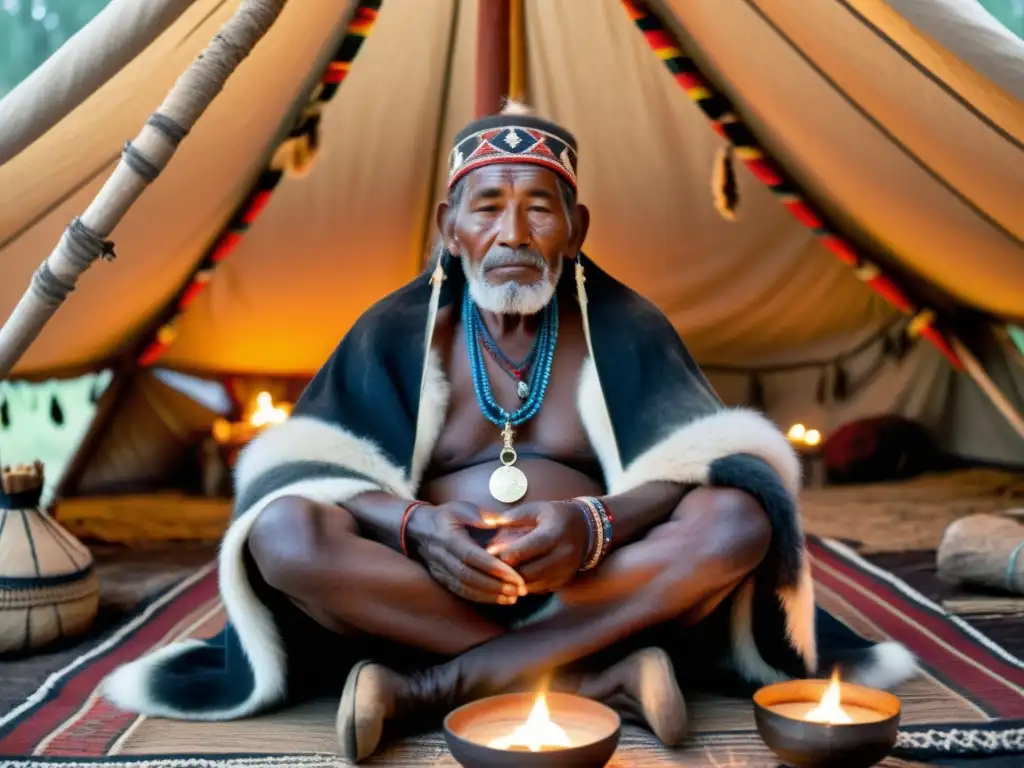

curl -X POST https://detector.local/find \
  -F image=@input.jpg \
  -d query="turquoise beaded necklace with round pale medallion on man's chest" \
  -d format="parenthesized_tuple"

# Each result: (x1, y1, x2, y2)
(462, 286, 558, 504)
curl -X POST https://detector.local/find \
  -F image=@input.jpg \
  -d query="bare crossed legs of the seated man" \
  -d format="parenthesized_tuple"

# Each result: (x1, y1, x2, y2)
(249, 487, 771, 758)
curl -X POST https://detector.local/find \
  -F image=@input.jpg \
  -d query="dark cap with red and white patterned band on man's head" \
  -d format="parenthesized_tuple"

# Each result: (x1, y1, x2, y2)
(447, 115, 577, 189)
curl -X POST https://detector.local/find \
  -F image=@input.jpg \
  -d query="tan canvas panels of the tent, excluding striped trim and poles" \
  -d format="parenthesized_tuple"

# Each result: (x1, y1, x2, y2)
(0, 0, 1024, 475)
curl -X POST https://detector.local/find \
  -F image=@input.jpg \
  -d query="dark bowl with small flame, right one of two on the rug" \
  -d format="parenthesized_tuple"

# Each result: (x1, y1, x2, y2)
(754, 673, 901, 768)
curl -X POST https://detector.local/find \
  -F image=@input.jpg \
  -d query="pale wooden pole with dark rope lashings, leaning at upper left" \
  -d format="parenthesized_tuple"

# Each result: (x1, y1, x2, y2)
(0, 0, 286, 377)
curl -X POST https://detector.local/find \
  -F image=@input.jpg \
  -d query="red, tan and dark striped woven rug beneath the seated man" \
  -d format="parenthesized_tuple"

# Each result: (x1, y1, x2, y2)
(0, 539, 1024, 768)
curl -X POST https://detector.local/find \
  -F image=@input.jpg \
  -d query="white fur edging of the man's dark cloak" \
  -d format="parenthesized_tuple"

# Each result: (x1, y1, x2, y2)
(103, 354, 913, 720)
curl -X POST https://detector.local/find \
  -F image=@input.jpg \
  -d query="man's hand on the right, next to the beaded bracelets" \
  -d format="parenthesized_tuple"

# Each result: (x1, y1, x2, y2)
(487, 502, 590, 594)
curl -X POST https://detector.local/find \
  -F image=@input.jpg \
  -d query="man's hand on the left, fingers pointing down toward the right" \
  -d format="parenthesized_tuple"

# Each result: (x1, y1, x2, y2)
(407, 502, 526, 605)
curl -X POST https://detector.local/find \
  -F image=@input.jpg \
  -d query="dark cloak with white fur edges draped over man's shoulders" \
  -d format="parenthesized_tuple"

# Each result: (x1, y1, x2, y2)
(104, 257, 914, 720)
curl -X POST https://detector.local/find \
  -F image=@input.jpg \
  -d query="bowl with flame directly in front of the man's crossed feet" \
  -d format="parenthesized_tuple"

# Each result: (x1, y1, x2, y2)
(444, 692, 622, 768)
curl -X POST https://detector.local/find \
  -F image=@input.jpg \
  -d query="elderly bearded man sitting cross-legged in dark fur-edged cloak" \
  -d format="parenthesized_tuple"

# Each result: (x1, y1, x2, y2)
(106, 105, 912, 760)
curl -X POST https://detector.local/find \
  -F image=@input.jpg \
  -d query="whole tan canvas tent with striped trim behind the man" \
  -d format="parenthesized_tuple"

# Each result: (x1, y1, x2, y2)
(0, 0, 1024, 505)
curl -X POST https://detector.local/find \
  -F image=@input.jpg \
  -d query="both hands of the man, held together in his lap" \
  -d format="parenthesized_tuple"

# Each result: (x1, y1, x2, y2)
(409, 502, 591, 605)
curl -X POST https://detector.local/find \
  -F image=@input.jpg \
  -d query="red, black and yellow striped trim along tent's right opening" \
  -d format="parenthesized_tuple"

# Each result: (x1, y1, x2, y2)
(622, 0, 965, 371)
